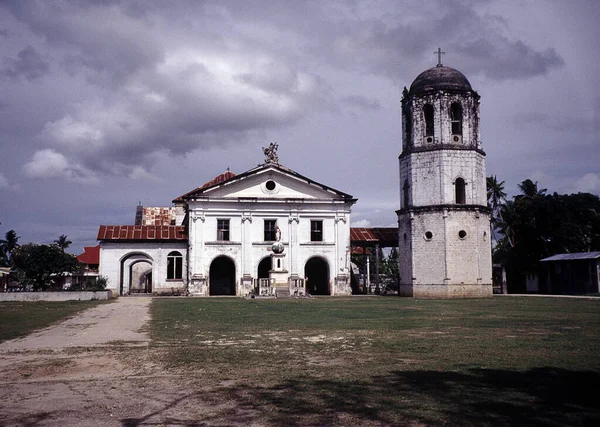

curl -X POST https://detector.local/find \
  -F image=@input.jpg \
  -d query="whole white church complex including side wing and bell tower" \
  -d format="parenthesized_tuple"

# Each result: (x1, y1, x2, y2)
(98, 53, 492, 298)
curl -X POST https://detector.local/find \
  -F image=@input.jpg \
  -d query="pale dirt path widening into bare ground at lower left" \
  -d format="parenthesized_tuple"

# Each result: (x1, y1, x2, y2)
(0, 297, 211, 426)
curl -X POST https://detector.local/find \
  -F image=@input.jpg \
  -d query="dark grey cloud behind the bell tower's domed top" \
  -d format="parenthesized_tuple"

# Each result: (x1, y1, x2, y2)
(312, 1, 564, 80)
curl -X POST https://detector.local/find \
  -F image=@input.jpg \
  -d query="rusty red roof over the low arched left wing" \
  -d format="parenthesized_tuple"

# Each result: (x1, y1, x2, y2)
(97, 225, 188, 241)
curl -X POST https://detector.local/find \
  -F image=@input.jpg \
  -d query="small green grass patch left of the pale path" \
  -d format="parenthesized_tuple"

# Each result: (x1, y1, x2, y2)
(0, 301, 101, 342)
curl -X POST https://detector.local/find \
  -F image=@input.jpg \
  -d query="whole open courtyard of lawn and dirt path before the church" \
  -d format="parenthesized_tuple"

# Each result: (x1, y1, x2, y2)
(0, 296, 600, 426)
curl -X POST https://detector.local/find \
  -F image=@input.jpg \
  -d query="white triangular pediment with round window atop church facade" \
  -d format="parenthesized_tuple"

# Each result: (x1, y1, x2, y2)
(182, 164, 352, 200)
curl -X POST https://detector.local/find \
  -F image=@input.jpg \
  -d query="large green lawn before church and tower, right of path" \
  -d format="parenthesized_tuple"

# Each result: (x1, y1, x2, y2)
(150, 297, 600, 427)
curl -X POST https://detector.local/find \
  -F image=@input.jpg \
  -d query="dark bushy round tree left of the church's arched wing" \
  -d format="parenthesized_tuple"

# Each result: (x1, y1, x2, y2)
(13, 243, 79, 291)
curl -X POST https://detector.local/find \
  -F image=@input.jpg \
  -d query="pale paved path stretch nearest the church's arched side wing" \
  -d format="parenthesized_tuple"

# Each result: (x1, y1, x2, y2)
(0, 297, 151, 354)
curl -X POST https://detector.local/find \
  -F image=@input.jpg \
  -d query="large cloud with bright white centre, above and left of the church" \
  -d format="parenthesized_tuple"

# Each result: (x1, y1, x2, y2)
(2, 2, 329, 179)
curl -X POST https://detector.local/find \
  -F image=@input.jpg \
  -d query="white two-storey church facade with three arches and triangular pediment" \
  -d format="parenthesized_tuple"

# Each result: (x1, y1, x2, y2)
(180, 164, 355, 295)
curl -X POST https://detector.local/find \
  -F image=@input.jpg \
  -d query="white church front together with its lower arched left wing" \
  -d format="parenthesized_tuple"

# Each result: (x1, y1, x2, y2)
(98, 163, 356, 296)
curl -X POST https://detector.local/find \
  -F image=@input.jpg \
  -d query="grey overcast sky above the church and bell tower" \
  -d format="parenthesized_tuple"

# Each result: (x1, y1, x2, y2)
(0, 0, 600, 253)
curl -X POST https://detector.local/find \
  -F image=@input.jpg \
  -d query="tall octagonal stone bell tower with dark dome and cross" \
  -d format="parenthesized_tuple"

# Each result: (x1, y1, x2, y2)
(397, 49, 492, 298)
